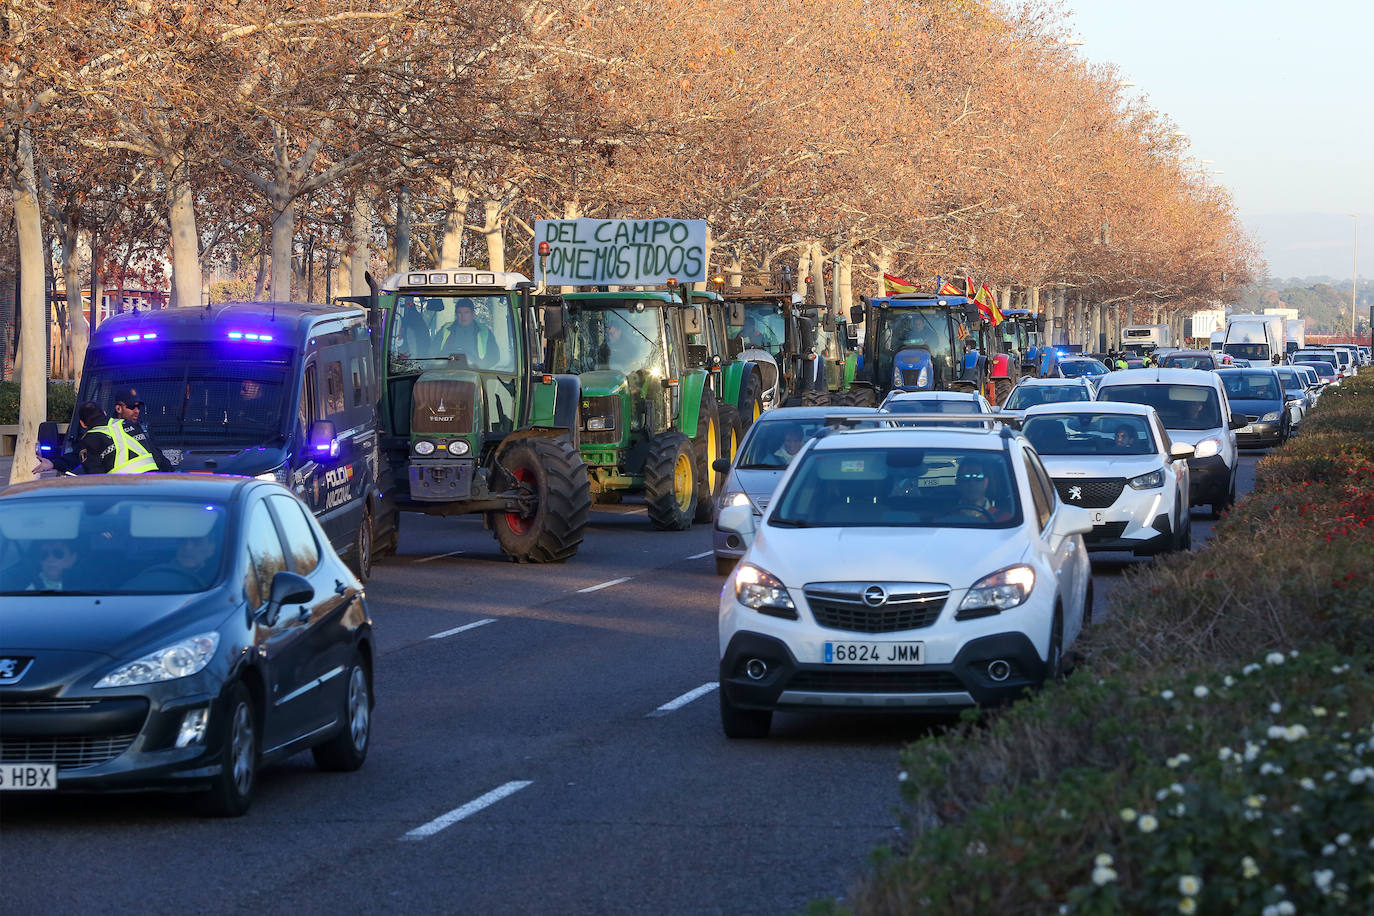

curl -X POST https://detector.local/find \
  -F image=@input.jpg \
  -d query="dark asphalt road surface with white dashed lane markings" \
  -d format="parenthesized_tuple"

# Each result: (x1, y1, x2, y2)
(0, 453, 1257, 915)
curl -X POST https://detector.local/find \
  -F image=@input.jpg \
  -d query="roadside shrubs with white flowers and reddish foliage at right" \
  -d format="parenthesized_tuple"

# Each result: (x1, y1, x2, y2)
(815, 372, 1374, 916)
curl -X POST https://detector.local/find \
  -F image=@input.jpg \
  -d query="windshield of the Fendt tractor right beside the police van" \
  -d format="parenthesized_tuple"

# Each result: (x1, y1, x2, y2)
(390, 293, 517, 372)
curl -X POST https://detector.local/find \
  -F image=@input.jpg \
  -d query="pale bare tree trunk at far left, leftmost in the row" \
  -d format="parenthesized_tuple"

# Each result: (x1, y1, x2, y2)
(10, 129, 46, 483)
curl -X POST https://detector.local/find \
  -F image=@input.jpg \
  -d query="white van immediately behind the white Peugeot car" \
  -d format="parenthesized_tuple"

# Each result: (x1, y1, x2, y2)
(1098, 369, 1245, 515)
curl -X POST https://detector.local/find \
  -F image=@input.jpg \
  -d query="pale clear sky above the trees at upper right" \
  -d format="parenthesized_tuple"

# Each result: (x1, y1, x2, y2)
(1063, 0, 1374, 283)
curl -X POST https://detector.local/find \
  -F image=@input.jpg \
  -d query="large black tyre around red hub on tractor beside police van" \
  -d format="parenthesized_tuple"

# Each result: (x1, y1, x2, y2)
(491, 437, 592, 563)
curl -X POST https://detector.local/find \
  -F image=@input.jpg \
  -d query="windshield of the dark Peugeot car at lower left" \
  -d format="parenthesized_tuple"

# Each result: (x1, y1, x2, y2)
(0, 496, 228, 598)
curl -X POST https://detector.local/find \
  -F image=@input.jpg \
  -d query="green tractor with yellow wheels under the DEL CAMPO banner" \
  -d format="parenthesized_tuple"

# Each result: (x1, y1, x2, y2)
(548, 290, 724, 530)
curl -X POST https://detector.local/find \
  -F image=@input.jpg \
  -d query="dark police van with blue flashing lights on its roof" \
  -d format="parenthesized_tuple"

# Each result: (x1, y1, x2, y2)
(50, 302, 398, 578)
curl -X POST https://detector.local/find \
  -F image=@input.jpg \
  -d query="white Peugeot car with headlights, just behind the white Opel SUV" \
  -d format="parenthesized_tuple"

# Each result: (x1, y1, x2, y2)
(1021, 401, 1193, 556)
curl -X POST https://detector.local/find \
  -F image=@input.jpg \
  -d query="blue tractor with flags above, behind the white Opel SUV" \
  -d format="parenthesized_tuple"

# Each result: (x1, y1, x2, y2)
(849, 293, 994, 401)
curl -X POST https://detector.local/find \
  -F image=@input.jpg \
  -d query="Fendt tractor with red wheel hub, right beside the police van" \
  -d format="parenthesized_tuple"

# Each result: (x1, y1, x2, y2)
(354, 268, 591, 563)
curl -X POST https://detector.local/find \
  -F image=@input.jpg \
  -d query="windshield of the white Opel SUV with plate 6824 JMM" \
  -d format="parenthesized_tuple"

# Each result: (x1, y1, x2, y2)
(768, 446, 1021, 527)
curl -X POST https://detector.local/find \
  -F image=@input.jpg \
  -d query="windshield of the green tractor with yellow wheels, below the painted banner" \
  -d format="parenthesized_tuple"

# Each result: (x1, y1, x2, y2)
(566, 301, 668, 378)
